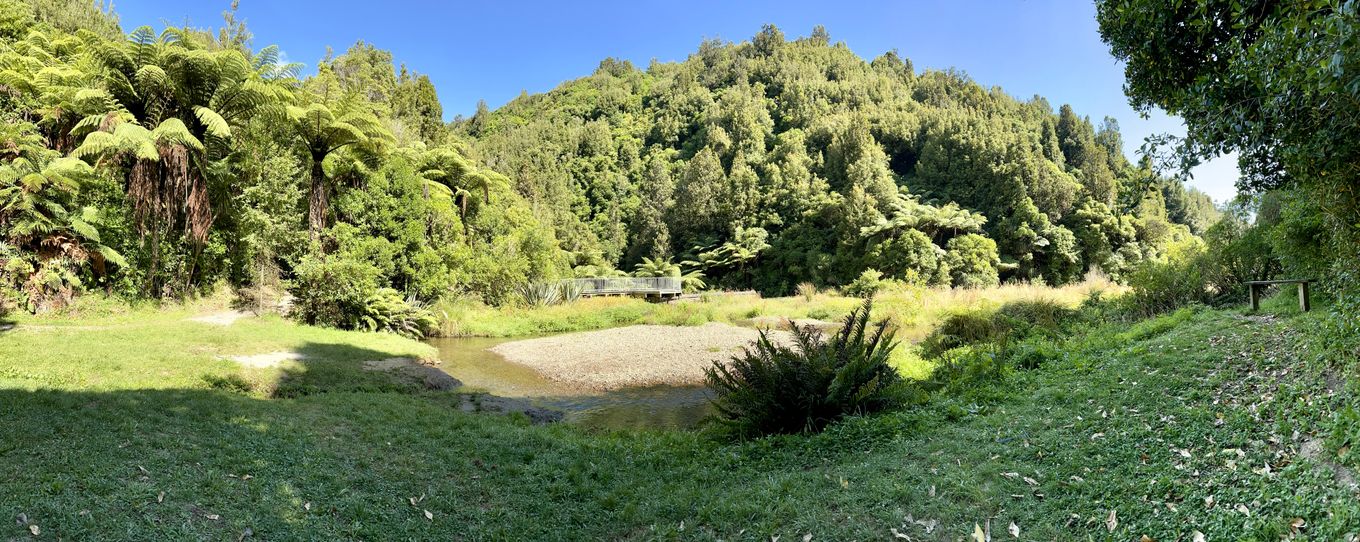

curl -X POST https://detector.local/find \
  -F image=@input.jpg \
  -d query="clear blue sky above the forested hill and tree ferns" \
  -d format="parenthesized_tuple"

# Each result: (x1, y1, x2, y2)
(116, 0, 1238, 201)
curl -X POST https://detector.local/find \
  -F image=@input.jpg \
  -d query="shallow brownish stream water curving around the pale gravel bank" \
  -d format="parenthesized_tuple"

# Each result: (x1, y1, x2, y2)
(428, 338, 711, 428)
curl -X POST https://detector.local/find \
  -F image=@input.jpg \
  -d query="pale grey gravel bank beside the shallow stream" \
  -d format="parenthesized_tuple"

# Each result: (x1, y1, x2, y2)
(491, 322, 789, 391)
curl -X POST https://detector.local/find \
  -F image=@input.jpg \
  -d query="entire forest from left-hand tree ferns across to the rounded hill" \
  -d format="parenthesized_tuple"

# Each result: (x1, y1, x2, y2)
(0, 0, 1216, 323)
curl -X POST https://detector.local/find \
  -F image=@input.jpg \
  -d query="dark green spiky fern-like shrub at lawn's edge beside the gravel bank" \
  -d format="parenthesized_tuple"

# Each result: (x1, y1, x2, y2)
(706, 302, 919, 436)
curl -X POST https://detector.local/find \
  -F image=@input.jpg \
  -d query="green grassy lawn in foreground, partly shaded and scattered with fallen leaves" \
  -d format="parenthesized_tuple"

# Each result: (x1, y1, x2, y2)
(0, 298, 1360, 541)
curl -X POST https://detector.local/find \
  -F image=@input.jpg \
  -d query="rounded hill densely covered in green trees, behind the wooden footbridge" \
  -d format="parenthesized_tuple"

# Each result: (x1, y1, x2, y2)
(456, 26, 1216, 292)
